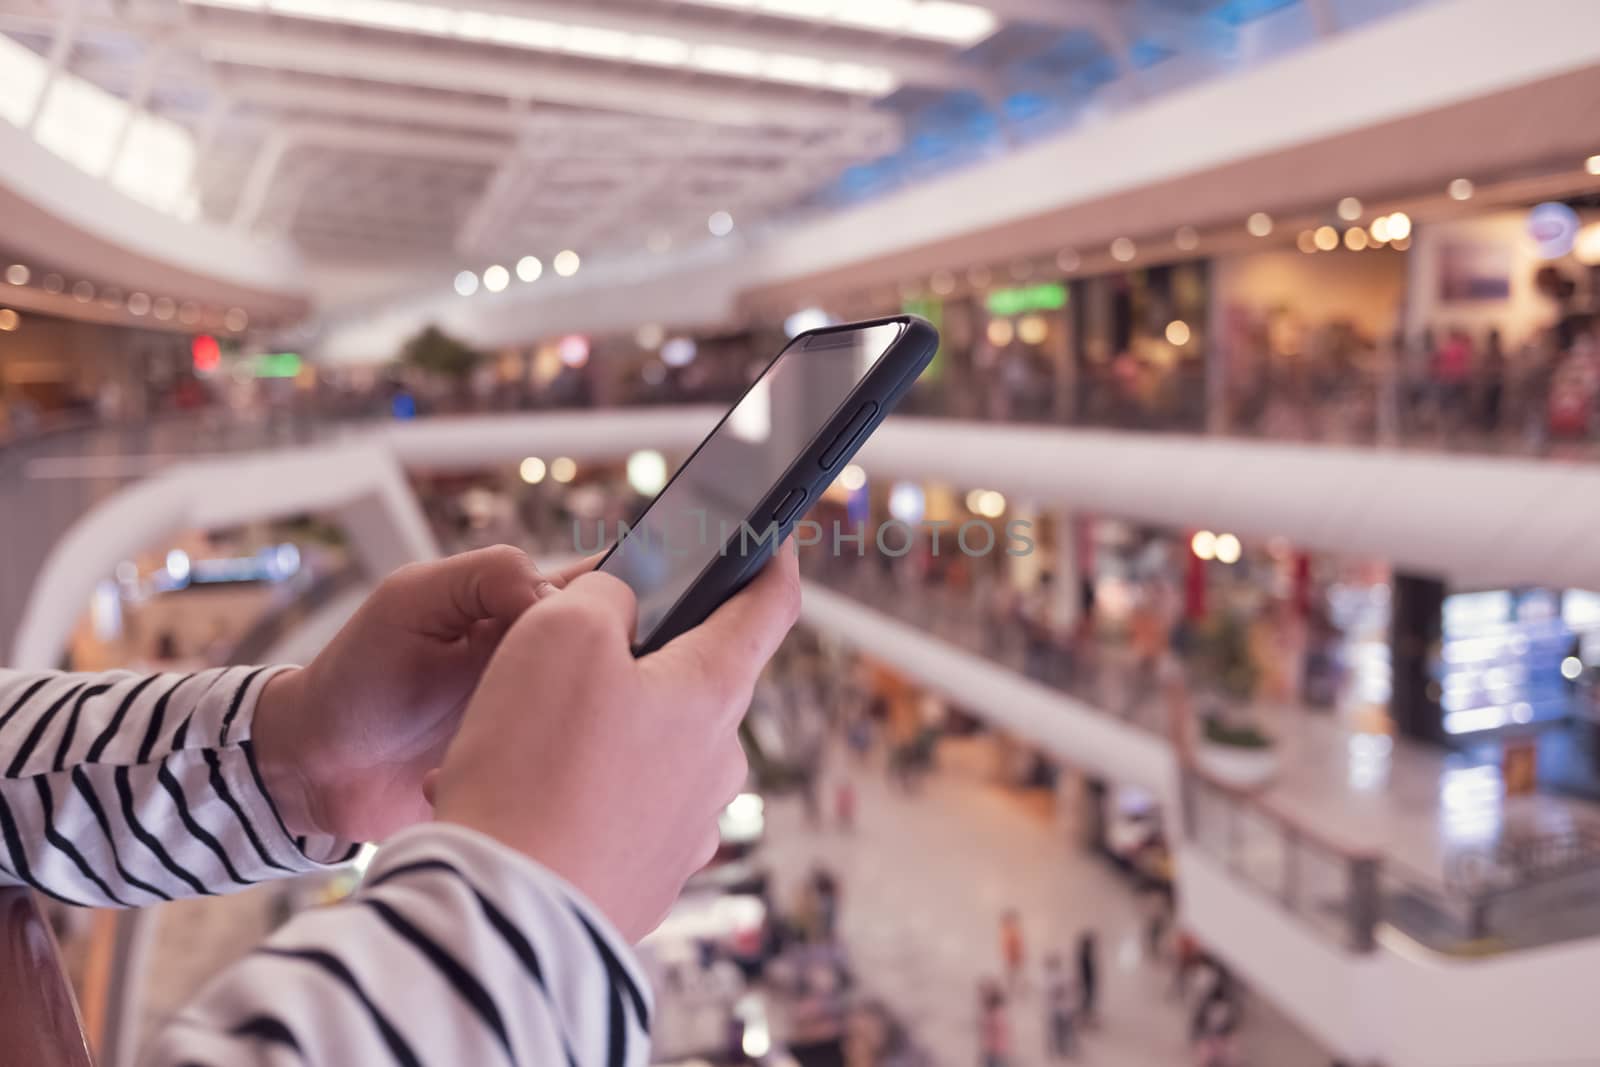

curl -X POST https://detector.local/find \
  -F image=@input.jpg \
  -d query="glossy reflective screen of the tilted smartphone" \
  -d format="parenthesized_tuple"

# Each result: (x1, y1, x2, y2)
(600, 323, 906, 643)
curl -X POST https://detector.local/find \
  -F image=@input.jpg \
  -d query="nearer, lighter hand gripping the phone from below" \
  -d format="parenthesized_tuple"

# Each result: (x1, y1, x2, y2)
(430, 545, 800, 939)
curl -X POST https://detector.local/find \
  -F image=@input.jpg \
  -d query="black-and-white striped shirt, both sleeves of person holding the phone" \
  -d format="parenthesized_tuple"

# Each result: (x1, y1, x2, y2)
(0, 667, 651, 1067)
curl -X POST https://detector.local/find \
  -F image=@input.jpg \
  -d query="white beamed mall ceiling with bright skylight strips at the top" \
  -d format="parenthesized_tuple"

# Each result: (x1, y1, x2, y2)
(0, 0, 1416, 292)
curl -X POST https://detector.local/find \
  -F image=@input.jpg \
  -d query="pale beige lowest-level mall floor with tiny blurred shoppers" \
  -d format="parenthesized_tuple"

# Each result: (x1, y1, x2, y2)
(762, 742, 1331, 1067)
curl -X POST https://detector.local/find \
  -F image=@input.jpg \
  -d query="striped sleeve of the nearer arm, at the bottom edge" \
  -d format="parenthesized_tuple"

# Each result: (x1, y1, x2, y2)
(144, 824, 651, 1067)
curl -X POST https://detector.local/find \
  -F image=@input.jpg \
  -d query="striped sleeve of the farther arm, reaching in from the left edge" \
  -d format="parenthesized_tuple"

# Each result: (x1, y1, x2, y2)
(0, 667, 355, 907)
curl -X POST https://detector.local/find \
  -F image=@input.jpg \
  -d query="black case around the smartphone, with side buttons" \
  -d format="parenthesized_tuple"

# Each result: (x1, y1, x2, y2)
(598, 315, 939, 656)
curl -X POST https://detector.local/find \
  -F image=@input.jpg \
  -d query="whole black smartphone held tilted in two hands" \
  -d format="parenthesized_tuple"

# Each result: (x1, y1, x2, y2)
(598, 315, 939, 656)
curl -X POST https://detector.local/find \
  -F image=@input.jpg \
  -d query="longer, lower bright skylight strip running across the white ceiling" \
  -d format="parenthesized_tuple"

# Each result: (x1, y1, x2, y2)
(187, 0, 902, 96)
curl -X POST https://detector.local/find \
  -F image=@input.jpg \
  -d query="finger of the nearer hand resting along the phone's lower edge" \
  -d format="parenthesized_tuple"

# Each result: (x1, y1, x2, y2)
(645, 539, 800, 710)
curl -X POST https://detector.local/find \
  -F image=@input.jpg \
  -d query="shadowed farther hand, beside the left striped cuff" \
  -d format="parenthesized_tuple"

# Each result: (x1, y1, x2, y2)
(253, 545, 595, 841)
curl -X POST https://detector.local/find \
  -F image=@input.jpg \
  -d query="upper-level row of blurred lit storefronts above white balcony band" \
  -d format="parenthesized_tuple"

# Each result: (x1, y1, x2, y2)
(0, 254, 1600, 467)
